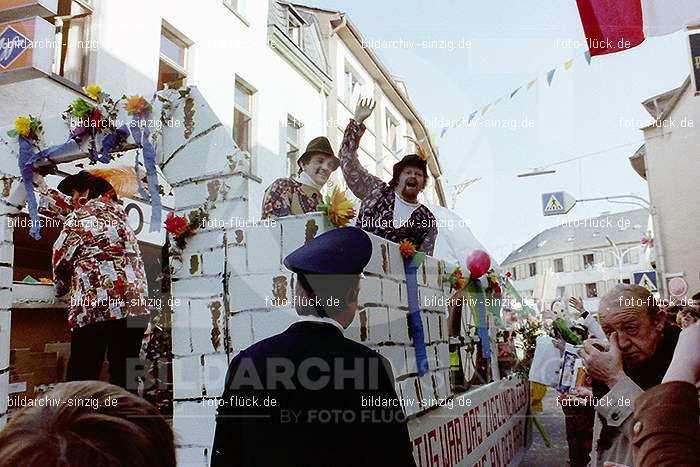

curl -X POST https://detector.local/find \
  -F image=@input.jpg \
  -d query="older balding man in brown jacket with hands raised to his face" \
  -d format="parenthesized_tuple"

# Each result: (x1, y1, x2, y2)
(580, 284, 679, 467)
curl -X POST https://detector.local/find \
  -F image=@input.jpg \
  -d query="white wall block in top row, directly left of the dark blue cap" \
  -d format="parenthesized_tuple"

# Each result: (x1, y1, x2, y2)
(246, 224, 287, 274)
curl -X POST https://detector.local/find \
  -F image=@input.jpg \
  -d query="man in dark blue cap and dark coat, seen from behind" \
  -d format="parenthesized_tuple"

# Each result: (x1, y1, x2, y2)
(211, 227, 415, 467)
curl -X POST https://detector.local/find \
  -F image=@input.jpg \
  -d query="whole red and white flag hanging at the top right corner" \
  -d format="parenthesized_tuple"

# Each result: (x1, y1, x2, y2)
(576, 0, 700, 56)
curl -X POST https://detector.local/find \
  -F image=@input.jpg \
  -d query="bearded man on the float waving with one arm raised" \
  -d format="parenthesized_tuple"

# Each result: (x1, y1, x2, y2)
(338, 100, 437, 255)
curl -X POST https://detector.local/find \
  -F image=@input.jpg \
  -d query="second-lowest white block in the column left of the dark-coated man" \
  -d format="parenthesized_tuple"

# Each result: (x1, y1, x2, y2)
(173, 399, 217, 447)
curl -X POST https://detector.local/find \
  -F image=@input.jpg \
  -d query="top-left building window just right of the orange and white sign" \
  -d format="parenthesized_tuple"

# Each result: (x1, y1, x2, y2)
(47, 0, 92, 86)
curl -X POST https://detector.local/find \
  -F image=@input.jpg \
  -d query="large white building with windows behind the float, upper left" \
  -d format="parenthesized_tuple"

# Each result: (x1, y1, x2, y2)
(0, 0, 444, 219)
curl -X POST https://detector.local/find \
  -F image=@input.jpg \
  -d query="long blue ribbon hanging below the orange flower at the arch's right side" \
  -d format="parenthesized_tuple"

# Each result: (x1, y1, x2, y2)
(130, 112, 161, 232)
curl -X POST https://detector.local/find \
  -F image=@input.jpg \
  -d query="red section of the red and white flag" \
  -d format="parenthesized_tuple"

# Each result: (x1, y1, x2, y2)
(576, 0, 644, 57)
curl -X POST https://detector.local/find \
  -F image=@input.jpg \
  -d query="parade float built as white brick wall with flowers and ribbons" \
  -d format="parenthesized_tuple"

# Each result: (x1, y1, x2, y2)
(0, 87, 532, 466)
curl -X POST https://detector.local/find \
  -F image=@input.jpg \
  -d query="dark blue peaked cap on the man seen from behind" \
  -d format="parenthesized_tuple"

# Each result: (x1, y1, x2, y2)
(284, 227, 372, 274)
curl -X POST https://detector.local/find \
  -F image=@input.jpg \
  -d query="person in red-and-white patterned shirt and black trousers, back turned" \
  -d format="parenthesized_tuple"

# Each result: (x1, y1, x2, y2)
(35, 172, 149, 389)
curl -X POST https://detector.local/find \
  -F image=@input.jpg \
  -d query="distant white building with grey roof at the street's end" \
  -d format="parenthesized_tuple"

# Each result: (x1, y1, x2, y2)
(502, 209, 653, 311)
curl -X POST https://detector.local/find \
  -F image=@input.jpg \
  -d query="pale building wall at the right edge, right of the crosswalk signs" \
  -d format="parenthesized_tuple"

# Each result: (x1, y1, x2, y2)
(630, 77, 700, 297)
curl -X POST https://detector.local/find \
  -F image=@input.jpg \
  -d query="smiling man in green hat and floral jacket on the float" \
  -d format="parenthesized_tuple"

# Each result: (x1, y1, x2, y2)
(262, 136, 340, 219)
